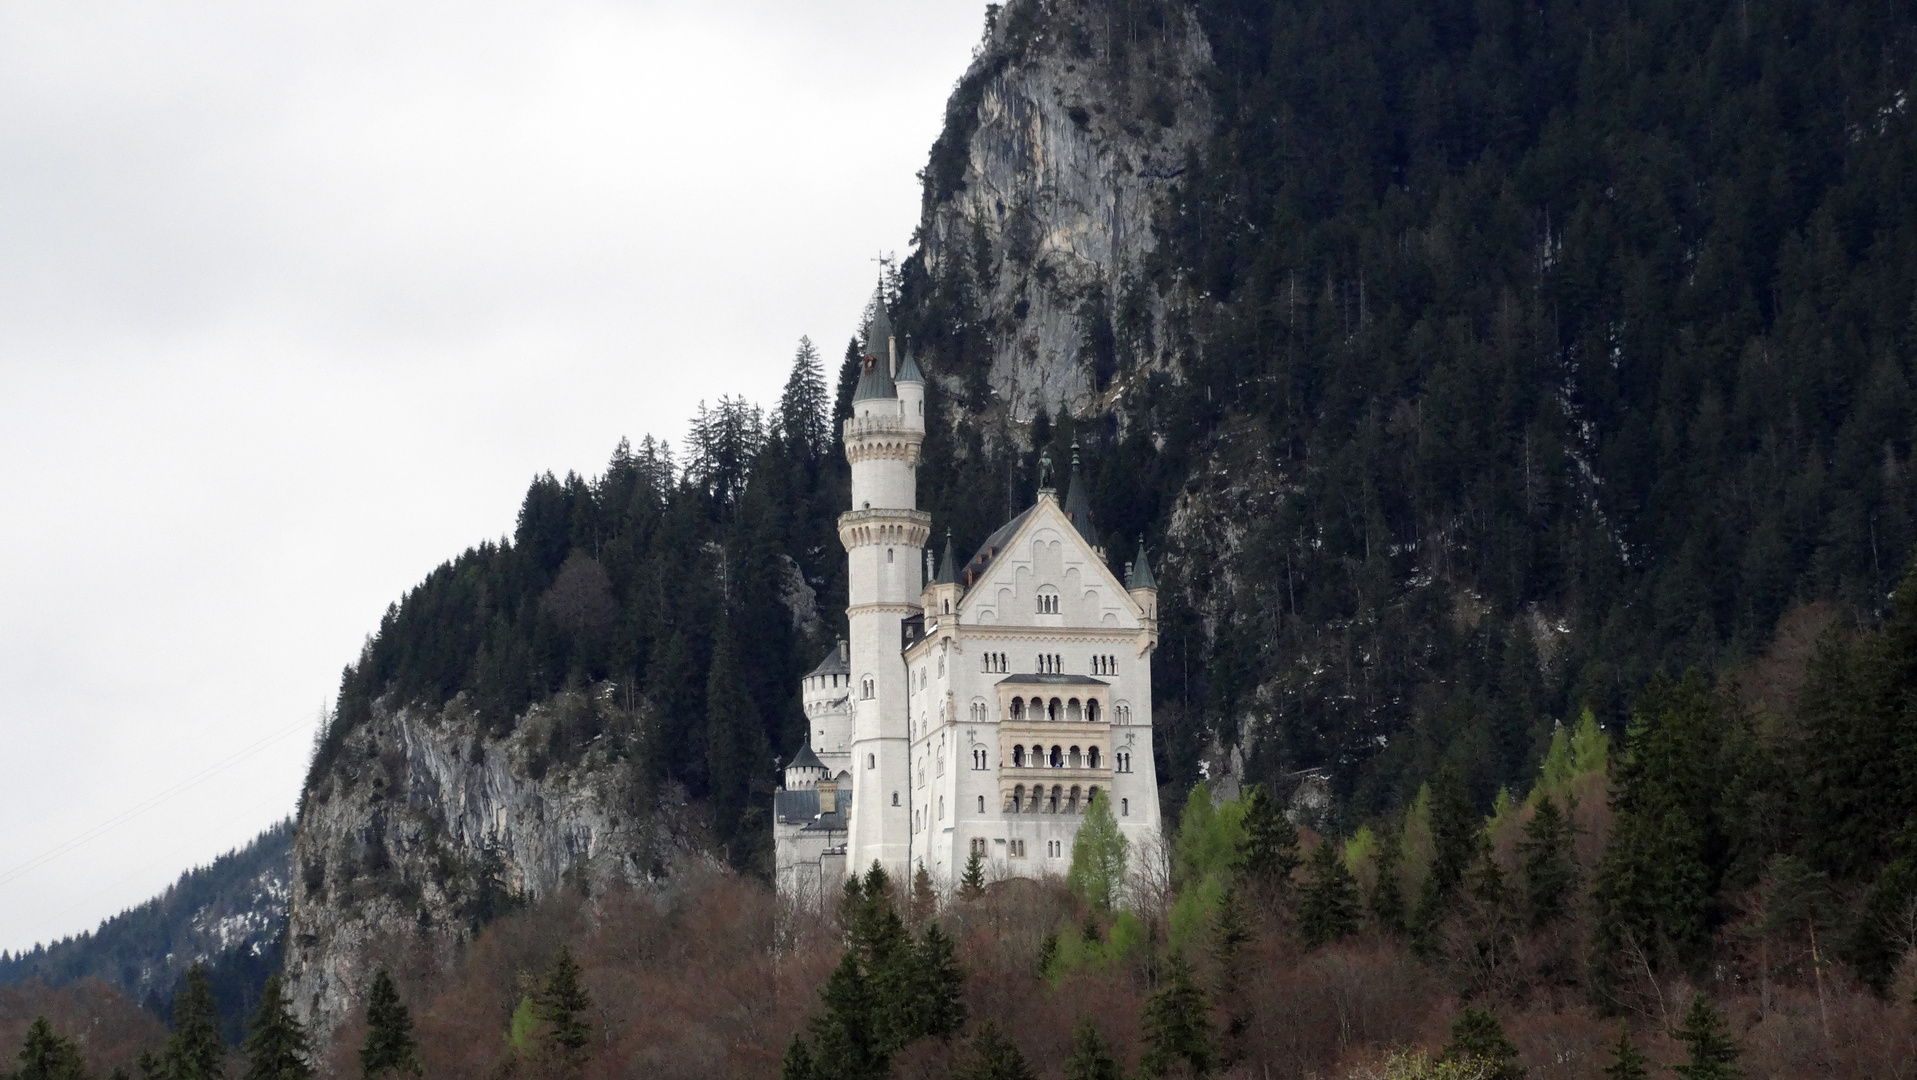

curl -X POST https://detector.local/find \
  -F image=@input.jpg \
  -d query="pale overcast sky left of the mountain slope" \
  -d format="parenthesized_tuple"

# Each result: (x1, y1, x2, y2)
(0, 0, 983, 950)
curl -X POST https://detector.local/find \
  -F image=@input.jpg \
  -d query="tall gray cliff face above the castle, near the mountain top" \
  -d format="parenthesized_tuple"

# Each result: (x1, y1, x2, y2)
(920, 2, 1212, 422)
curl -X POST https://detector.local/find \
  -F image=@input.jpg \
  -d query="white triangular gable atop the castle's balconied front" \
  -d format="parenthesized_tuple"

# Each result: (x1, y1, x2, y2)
(959, 493, 1141, 629)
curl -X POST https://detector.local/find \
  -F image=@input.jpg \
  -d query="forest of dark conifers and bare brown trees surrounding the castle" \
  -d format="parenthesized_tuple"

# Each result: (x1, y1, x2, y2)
(11, 0, 1917, 1080)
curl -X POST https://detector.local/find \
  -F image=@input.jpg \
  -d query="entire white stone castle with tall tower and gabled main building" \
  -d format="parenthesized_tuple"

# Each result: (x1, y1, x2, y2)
(773, 291, 1158, 902)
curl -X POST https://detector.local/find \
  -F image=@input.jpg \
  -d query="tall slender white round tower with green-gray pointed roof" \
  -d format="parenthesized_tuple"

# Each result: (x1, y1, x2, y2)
(840, 292, 932, 877)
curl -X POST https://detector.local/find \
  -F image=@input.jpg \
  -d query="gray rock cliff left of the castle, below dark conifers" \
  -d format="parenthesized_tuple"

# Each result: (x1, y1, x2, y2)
(286, 687, 688, 1042)
